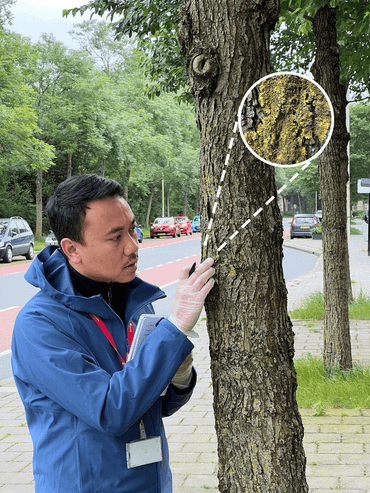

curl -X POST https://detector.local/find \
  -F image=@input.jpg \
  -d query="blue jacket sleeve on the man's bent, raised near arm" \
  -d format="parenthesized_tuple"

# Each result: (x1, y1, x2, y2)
(12, 310, 193, 436)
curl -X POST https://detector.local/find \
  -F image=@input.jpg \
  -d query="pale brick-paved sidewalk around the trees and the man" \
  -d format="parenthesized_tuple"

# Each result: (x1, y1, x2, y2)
(0, 236, 370, 493)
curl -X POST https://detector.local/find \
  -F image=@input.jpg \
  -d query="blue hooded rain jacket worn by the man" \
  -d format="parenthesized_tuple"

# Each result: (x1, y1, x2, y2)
(12, 247, 196, 493)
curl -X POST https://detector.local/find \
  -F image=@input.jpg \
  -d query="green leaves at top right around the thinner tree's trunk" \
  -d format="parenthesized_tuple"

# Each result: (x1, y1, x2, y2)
(272, 0, 370, 98)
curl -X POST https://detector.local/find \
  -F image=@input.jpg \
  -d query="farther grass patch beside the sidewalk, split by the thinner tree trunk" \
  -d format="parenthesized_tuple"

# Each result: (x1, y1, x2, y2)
(290, 292, 370, 320)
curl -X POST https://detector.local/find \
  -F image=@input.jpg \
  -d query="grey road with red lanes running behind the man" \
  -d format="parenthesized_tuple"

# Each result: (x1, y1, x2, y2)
(0, 234, 317, 379)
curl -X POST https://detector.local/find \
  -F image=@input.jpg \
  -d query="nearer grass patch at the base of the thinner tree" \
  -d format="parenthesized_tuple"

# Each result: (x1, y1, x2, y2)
(294, 354, 370, 408)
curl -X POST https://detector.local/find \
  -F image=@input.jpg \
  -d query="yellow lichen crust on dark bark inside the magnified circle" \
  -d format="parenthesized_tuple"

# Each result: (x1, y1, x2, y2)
(244, 74, 331, 164)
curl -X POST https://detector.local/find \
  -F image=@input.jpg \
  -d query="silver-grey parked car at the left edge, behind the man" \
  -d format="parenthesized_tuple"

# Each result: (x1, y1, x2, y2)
(0, 216, 35, 263)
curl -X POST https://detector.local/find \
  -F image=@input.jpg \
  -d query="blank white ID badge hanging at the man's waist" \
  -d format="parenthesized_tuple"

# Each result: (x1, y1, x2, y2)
(126, 437, 162, 469)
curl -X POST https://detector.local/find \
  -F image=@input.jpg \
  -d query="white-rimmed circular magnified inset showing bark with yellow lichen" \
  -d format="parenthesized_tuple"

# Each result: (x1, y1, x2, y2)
(238, 72, 334, 168)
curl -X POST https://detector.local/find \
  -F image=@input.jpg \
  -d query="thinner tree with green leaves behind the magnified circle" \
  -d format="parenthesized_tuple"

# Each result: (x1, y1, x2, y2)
(273, 0, 370, 369)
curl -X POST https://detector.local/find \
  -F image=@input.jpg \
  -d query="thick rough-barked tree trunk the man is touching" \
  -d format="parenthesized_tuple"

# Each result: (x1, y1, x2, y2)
(178, 0, 308, 493)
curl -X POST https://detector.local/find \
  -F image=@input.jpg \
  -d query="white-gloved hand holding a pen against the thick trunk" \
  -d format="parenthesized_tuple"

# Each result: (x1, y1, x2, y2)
(169, 258, 215, 337)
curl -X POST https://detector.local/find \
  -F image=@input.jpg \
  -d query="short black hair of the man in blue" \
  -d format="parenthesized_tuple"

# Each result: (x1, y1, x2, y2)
(45, 174, 124, 245)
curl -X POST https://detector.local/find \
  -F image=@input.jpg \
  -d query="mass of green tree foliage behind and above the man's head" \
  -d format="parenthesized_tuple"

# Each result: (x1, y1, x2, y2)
(0, 22, 199, 233)
